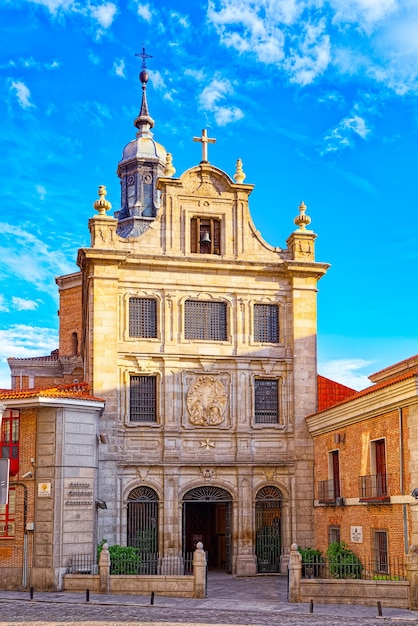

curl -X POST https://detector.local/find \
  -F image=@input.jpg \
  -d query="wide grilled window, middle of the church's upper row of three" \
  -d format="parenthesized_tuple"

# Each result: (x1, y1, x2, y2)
(184, 300, 227, 341)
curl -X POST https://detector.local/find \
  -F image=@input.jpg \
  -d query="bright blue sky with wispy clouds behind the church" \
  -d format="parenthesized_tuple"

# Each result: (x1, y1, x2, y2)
(0, 0, 418, 388)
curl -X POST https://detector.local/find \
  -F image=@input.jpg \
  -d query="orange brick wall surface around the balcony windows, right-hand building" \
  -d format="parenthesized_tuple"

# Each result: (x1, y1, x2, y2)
(314, 408, 411, 559)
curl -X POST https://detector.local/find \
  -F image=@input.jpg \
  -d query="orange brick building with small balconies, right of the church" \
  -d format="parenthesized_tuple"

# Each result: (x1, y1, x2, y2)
(307, 357, 418, 575)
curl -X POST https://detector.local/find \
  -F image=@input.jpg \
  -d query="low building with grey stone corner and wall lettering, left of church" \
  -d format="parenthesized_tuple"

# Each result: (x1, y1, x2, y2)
(0, 384, 104, 590)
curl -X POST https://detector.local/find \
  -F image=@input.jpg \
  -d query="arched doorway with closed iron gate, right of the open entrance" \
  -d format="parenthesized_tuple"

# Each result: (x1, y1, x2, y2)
(255, 485, 283, 572)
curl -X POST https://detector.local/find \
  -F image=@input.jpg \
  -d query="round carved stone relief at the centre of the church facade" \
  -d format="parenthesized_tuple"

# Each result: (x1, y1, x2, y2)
(186, 376, 228, 426)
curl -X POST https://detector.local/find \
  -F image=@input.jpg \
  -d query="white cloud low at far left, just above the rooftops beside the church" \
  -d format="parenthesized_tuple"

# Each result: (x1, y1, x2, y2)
(0, 324, 58, 389)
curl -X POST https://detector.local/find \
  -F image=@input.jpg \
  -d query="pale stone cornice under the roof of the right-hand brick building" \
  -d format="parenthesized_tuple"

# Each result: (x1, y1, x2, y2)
(306, 376, 418, 436)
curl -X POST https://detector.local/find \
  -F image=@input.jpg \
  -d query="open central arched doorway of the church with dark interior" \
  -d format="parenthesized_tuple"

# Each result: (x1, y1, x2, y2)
(183, 486, 232, 572)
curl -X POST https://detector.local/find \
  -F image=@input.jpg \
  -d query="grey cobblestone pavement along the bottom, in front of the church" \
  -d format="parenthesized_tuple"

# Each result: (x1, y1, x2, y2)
(0, 574, 418, 626)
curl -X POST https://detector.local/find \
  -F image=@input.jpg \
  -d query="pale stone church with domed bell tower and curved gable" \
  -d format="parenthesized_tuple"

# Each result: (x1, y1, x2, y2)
(5, 62, 328, 576)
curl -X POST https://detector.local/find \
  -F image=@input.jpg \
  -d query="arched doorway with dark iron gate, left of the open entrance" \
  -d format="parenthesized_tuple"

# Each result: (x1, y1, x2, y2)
(127, 487, 158, 559)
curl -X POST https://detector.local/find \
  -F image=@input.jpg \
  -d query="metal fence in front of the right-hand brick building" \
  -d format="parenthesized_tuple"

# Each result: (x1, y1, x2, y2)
(302, 555, 406, 581)
